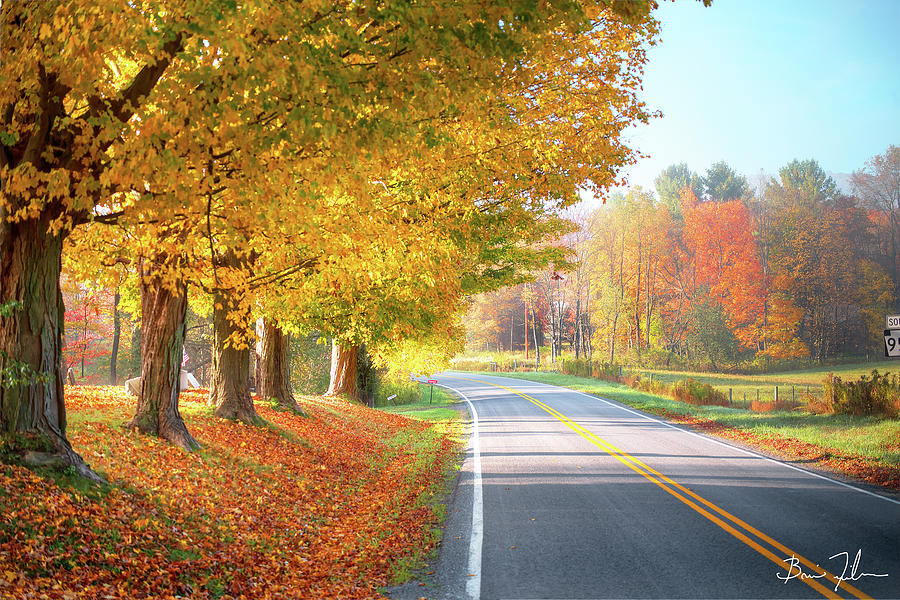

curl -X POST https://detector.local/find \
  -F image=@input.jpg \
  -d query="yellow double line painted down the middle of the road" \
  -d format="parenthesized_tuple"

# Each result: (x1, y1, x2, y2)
(458, 377, 871, 600)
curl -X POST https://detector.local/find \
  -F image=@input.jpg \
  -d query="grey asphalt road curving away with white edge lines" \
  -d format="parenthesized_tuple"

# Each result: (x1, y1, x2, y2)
(397, 373, 900, 599)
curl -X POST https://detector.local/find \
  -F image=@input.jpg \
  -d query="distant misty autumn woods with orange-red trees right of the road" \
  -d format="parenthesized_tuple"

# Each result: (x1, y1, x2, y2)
(467, 146, 900, 370)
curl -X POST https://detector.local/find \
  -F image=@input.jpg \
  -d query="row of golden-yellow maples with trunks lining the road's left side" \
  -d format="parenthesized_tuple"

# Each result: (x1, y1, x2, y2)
(0, 0, 657, 477)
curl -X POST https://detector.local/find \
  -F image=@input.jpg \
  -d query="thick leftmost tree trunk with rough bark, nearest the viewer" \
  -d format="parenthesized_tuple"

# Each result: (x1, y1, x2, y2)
(0, 213, 103, 481)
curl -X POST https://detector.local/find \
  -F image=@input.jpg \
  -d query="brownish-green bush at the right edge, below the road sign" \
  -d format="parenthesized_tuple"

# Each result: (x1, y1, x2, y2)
(822, 369, 900, 417)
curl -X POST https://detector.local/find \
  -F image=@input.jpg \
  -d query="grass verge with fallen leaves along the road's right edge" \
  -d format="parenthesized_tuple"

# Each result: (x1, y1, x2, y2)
(464, 370, 900, 489)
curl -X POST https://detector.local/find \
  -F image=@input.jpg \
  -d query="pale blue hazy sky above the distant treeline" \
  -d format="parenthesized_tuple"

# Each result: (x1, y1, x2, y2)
(590, 0, 900, 204)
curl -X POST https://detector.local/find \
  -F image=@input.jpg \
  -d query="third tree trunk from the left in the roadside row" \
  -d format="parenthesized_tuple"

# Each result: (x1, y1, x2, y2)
(209, 290, 259, 425)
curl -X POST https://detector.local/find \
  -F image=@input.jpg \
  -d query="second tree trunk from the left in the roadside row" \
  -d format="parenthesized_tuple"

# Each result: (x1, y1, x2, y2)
(126, 260, 200, 450)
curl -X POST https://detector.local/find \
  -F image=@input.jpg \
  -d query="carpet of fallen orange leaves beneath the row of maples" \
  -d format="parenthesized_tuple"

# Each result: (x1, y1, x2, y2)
(0, 387, 456, 599)
